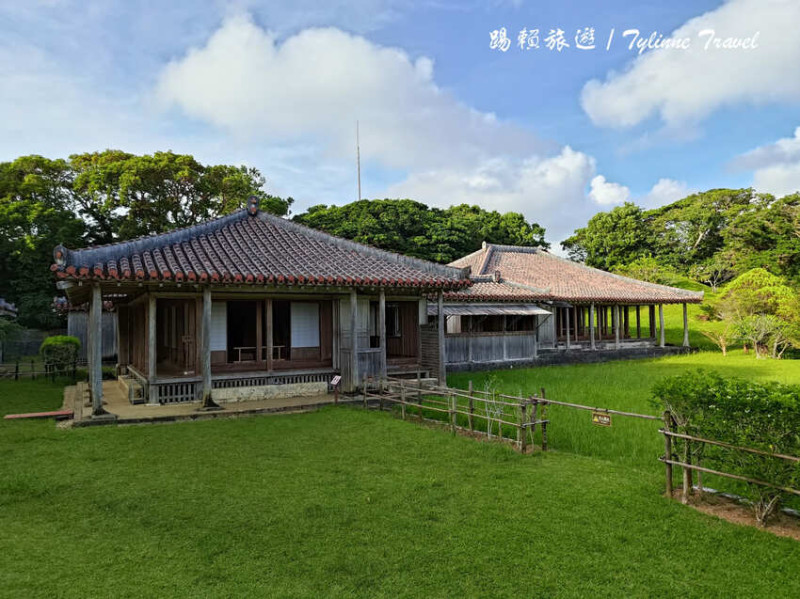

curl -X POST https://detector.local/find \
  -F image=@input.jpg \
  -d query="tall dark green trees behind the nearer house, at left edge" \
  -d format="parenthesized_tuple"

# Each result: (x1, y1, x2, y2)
(0, 150, 293, 328)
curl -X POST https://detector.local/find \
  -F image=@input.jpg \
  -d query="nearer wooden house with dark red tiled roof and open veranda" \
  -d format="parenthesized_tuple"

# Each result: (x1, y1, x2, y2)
(52, 199, 470, 414)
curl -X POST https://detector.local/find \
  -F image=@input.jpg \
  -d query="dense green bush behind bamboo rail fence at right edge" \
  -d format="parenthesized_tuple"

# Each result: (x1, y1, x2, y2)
(653, 370, 800, 524)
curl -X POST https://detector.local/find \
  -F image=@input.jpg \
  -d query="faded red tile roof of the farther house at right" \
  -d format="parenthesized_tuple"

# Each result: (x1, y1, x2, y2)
(447, 244, 703, 304)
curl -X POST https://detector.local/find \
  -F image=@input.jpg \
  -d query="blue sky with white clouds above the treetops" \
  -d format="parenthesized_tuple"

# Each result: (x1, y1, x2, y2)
(0, 0, 800, 242)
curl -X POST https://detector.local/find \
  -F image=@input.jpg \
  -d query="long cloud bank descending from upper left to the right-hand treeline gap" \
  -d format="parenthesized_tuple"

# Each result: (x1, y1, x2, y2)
(156, 16, 627, 241)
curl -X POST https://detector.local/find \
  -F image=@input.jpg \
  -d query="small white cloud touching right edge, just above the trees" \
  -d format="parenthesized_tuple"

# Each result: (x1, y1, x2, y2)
(733, 127, 800, 197)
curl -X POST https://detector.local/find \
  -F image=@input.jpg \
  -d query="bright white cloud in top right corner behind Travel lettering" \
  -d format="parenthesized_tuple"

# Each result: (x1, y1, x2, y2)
(581, 0, 800, 129)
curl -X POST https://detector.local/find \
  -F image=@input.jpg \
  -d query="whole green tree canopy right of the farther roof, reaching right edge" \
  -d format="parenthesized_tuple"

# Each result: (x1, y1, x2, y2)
(562, 189, 800, 287)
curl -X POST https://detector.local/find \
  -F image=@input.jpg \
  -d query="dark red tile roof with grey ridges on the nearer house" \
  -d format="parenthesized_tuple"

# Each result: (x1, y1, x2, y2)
(51, 207, 470, 289)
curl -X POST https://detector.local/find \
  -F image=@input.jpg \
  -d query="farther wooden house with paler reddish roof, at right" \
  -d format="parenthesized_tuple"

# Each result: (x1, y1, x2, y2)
(438, 243, 703, 370)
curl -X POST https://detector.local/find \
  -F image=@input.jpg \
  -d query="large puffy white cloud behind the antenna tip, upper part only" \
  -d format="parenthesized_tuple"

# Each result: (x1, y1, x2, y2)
(157, 16, 545, 169)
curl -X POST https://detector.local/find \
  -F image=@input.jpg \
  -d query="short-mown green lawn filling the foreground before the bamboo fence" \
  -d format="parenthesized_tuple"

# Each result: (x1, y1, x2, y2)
(0, 378, 800, 597)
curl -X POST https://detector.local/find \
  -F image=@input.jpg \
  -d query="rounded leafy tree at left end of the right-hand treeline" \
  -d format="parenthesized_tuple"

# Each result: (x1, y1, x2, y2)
(561, 202, 653, 270)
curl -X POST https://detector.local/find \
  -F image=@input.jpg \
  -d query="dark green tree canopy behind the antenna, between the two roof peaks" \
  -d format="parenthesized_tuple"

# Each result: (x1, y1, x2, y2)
(294, 199, 548, 263)
